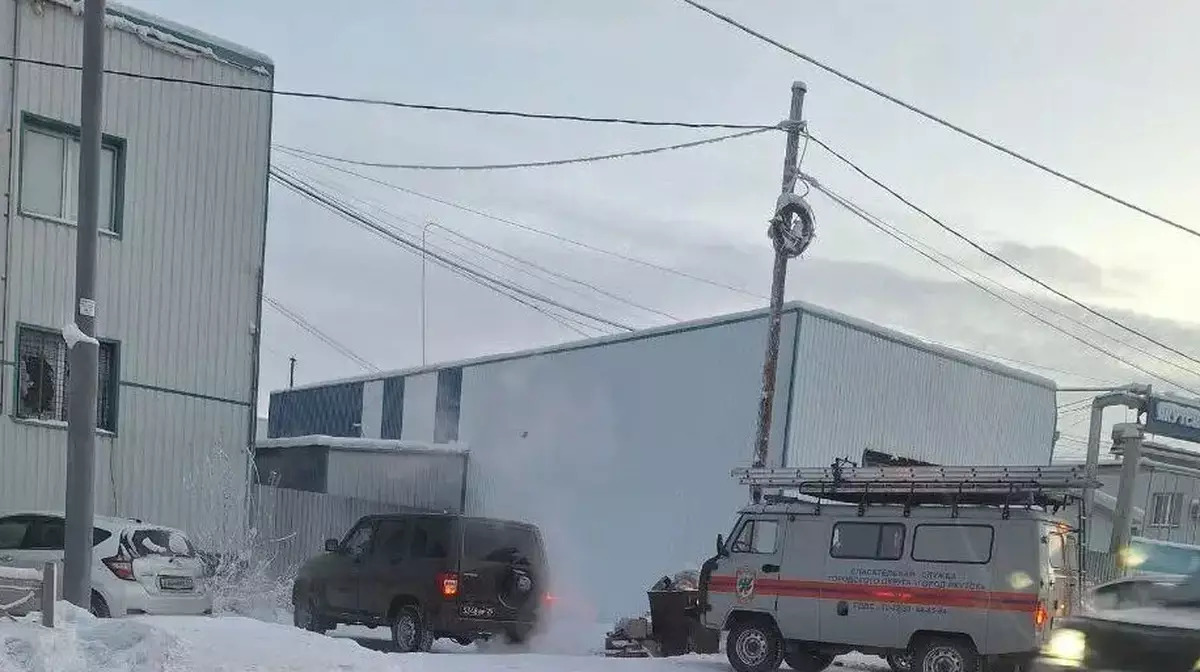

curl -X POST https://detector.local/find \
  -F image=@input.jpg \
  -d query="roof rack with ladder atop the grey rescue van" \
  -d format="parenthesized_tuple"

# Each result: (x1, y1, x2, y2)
(733, 462, 1100, 514)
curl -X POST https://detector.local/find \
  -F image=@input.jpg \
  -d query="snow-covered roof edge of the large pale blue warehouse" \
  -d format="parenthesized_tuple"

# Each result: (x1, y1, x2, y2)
(278, 301, 1058, 396)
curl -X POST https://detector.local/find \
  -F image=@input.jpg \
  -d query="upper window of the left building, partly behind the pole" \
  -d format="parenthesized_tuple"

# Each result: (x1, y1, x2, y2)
(20, 114, 125, 233)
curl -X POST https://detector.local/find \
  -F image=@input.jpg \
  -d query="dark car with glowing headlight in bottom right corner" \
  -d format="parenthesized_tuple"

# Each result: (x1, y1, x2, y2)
(1033, 572, 1200, 672)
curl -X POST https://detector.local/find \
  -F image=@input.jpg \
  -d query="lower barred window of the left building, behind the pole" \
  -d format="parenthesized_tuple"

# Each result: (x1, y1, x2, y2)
(16, 326, 118, 432)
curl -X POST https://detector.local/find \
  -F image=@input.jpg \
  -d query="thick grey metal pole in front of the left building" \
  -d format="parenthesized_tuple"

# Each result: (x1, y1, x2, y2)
(62, 0, 104, 608)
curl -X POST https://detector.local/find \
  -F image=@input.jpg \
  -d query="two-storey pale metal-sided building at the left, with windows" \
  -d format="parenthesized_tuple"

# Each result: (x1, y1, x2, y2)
(0, 0, 274, 540)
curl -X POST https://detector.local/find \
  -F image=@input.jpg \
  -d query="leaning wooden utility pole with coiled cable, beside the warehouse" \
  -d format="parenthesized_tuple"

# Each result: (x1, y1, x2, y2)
(750, 82, 808, 503)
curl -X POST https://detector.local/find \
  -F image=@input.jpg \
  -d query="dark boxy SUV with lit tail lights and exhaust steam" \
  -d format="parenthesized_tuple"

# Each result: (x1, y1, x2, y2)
(292, 514, 548, 652)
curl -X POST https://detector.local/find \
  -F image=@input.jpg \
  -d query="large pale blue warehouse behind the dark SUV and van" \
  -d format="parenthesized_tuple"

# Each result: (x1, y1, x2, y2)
(269, 304, 1056, 616)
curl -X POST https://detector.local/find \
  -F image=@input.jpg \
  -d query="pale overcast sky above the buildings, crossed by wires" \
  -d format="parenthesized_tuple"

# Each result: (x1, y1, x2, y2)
(128, 0, 1200, 453)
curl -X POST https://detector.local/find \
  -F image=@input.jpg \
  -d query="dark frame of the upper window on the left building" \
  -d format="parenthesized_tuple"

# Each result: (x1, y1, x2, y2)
(16, 112, 128, 239)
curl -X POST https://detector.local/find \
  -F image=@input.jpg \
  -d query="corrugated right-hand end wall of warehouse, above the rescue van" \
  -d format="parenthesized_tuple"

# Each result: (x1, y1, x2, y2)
(787, 312, 1057, 467)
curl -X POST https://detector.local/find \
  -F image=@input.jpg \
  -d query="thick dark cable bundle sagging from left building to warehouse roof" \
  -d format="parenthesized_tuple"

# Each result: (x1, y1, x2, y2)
(270, 167, 634, 331)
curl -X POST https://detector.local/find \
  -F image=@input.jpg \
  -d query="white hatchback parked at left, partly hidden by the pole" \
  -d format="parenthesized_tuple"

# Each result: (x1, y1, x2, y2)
(0, 512, 212, 618)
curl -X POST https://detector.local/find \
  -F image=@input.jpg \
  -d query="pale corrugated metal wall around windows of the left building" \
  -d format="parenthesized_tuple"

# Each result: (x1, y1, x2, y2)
(0, 0, 271, 540)
